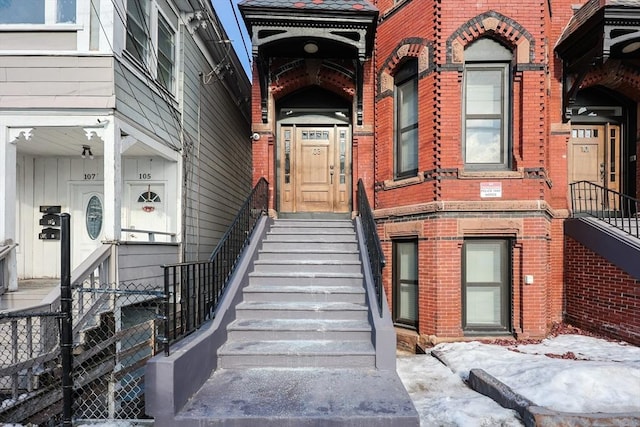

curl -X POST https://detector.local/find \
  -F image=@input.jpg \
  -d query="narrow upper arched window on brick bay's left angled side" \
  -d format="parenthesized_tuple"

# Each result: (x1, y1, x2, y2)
(394, 58, 418, 179)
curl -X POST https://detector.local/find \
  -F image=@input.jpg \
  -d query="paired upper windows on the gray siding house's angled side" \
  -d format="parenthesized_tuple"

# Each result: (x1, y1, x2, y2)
(125, 0, 176, 91)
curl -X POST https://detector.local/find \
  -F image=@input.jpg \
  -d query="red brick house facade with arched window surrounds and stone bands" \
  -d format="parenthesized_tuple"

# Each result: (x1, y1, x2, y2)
(244, 0, 640, 342)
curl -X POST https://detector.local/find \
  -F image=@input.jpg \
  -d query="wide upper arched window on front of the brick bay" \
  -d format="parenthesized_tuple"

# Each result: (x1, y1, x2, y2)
(463, 38, 512, 170)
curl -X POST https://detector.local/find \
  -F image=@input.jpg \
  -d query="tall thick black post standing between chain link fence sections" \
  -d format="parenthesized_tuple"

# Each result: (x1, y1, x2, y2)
(60, 213, 73, 426)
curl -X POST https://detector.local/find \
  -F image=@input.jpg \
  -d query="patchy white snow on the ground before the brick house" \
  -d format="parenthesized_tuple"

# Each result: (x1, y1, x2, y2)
(398, 335, 640, 427)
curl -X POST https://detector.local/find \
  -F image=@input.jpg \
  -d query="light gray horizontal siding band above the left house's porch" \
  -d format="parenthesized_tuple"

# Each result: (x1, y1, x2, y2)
(0, 56, 115, 109)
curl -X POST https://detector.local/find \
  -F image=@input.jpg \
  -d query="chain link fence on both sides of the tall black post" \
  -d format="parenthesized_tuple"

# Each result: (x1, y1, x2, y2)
(0, 280, 165, 426)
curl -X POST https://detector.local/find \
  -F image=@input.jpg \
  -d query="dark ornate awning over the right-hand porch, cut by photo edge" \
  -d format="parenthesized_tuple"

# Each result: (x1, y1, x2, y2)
(555, 0, 640, 121)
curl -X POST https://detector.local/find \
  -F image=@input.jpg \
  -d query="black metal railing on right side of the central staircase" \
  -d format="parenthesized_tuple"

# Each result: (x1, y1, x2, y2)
(356, 179, 386, 316)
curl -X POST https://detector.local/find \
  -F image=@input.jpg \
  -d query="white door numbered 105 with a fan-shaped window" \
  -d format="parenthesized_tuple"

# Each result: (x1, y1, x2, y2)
(122, 183, 170, 242)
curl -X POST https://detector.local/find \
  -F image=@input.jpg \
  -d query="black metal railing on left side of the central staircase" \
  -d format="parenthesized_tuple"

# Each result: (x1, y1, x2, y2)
(160, 178, 269, 356)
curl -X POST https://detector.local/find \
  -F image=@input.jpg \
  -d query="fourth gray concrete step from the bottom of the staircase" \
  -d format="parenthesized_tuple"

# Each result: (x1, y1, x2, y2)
(243, 285, 366, 304)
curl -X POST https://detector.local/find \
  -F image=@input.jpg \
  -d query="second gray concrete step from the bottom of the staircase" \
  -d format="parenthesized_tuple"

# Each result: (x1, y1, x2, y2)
(227, 319, 371, 341)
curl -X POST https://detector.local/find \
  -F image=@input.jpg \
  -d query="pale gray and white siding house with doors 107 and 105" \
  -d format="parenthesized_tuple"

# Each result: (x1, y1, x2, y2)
(0, 0, 251, 294)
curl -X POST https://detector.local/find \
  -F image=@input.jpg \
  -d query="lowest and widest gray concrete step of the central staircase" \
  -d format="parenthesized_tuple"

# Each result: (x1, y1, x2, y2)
(218, 337, 376, 369)
